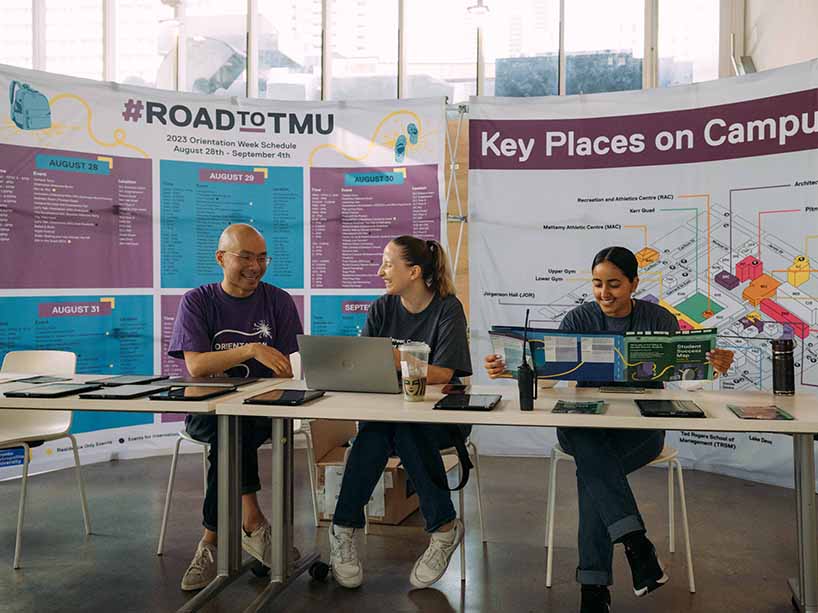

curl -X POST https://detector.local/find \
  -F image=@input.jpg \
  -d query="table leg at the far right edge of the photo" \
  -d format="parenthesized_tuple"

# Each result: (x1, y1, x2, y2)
(789, 434, 818, 613)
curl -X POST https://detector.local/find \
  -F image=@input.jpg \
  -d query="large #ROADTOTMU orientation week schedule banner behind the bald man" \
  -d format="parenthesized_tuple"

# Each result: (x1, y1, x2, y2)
(0, 66, 446, 478)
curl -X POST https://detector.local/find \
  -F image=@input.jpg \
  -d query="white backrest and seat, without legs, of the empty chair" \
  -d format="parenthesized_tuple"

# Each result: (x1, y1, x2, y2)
(0, 350, 77, 443)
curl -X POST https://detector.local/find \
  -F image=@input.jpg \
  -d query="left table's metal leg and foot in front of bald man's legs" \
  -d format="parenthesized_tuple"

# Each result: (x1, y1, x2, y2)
(178, 415, 252, 613)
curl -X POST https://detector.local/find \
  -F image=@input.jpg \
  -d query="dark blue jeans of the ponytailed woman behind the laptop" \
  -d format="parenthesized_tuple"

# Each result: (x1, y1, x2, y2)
(332, 422, 457, 532)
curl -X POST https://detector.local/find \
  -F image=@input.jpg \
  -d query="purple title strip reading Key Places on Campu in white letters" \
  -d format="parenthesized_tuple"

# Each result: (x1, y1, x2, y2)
(469, 89, 818, 170)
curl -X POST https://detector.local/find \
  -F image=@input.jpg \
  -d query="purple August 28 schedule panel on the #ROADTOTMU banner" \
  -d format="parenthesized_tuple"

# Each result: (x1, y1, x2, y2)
(0, 144, 153, 289)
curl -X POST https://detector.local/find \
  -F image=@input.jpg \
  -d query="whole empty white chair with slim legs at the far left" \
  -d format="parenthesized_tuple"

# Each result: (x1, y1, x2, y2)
(0, 351, 91, 569)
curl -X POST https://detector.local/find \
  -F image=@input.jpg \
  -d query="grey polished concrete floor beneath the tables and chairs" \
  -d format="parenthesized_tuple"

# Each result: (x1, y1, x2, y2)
(0, 450, 797, 613)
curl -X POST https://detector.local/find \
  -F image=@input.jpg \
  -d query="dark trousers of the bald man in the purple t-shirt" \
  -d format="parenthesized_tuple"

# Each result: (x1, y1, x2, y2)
(185, 414, 272, 532)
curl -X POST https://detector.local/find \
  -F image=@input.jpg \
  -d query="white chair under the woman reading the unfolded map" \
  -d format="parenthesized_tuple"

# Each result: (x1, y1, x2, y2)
(545, 445, 696, 594)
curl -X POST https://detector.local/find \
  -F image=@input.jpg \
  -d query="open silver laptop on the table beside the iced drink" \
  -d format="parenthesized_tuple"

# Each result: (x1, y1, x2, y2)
(298, 334, 401, 394)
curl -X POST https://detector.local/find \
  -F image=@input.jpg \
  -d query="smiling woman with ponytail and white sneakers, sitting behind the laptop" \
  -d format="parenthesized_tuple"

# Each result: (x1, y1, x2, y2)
(329, 236, 471, 588)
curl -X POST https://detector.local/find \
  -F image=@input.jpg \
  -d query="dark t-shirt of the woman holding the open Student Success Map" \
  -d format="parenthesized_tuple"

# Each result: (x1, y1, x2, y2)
(560, 300, 679, 389)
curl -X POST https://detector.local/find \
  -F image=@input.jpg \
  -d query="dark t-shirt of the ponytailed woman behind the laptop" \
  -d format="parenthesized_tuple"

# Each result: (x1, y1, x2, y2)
(361, 294, 472, 377)
